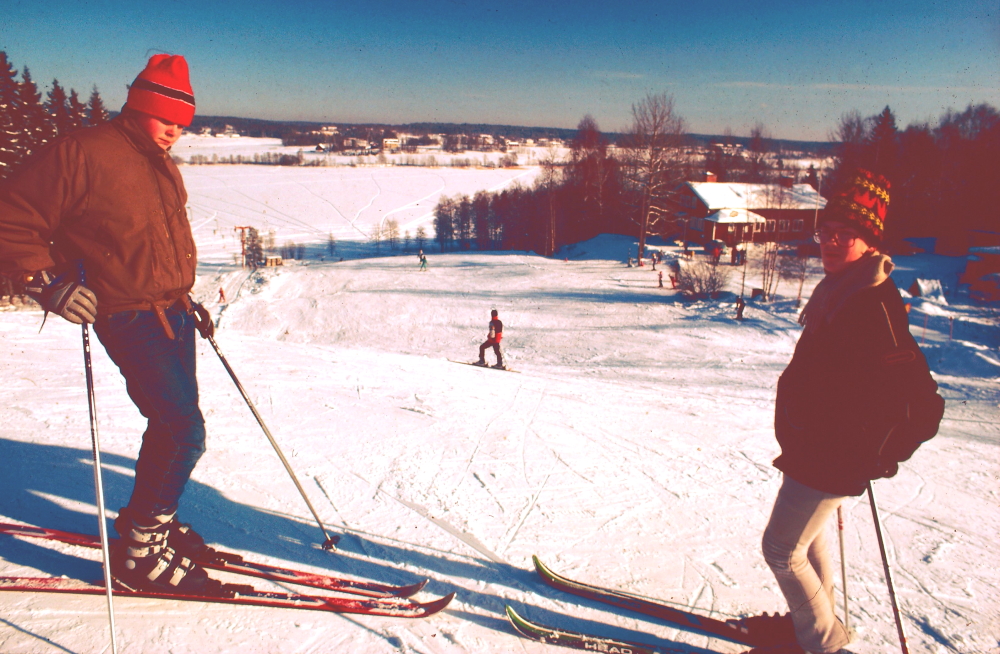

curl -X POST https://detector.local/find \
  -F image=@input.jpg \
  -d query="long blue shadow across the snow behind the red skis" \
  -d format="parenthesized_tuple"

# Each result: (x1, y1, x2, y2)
(0, 438, 720, 654)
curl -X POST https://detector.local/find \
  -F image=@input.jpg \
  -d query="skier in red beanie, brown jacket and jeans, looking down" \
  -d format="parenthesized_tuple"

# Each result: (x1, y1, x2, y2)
(0, 55, 219, 593)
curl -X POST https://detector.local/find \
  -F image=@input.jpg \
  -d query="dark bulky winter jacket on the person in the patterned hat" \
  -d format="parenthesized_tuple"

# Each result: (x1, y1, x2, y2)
(774, 279, 944, 495)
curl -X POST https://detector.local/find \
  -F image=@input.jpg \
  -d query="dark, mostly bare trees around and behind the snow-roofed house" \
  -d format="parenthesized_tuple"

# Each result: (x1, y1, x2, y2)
(434, 93, 1000, 257)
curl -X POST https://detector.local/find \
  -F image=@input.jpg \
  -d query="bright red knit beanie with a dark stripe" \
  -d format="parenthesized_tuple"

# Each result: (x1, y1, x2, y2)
(125, 55, 194, 127)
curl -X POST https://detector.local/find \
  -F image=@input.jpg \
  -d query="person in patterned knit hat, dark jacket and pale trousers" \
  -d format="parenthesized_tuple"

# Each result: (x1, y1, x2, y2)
(743, 170, 944, 654)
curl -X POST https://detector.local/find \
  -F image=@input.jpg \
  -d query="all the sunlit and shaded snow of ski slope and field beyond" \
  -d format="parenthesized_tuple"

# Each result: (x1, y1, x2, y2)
(0, 160, 1000, 654)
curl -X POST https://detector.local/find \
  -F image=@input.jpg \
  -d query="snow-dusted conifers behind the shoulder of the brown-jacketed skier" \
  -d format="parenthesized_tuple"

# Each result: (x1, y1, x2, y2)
(0, 50, 109, 179)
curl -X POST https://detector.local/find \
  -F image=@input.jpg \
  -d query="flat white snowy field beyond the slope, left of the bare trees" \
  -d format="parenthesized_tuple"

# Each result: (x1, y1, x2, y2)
(181, 164, 539, 263)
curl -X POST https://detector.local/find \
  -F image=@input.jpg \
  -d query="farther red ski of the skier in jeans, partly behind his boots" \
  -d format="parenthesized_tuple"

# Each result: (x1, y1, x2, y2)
(0, 522, 427, 597)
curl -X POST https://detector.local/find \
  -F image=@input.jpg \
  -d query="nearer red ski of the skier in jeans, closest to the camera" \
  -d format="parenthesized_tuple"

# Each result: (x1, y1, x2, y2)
(0, 577, 455, 618)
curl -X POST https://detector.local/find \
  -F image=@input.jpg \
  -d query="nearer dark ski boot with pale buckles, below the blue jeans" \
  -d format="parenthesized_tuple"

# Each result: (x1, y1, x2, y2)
(111, 511, 222, 595)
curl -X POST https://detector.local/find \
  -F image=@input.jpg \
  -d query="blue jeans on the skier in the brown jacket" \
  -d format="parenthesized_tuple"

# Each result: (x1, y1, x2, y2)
(94, 307, 205, 516)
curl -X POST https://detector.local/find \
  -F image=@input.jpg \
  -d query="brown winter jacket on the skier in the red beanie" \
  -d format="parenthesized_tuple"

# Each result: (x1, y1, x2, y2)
(0, 114, 197, 326)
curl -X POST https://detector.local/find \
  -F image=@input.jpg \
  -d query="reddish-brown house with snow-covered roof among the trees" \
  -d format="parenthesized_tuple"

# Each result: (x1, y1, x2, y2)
(676, 173, 826, 246)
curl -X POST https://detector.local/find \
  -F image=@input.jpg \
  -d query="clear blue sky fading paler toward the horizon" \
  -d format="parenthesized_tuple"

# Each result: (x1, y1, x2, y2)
(0, 0, 1000, 140)
